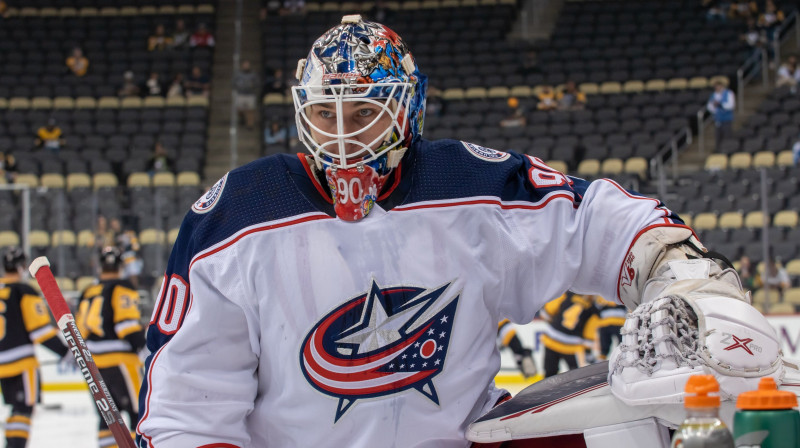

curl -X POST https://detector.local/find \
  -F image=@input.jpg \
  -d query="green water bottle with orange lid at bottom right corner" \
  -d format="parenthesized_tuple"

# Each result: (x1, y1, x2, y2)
(733, 377, 800, 448)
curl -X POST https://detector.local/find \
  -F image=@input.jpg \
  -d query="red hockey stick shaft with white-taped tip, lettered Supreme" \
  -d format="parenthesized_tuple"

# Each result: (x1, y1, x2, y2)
(28, 257, 136, 448)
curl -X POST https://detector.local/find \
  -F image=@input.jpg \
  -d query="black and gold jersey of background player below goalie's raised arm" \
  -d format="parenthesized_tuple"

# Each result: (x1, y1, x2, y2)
(540, 293, 599, 355)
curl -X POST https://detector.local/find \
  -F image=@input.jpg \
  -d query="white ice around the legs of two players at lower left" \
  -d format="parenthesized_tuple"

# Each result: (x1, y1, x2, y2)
(0, 390, 131, 448)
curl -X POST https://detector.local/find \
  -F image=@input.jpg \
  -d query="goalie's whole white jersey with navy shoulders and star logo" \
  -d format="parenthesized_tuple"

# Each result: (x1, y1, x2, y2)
(137, 140, 683, 448)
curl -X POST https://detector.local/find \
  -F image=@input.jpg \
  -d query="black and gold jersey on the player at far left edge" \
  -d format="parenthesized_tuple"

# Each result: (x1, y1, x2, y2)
(0, 278, 59, 378)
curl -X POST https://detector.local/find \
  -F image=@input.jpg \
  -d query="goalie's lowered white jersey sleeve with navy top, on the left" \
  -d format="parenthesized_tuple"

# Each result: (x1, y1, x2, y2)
(137, 212, 260, 448)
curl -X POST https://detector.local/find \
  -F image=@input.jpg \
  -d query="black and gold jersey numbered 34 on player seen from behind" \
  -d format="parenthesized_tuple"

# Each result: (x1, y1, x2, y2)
(75, 279, 144, 368)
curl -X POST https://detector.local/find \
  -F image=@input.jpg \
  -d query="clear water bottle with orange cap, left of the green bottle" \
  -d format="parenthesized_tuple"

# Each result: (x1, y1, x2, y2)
(671, 375, 734, 448)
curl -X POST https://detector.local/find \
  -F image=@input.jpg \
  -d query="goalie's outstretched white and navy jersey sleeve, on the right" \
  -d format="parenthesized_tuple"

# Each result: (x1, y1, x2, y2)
(500, 156, 686, 320)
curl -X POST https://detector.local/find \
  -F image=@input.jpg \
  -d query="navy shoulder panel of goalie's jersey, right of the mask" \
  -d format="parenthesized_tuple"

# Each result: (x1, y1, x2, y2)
(417, 140, 589, 204)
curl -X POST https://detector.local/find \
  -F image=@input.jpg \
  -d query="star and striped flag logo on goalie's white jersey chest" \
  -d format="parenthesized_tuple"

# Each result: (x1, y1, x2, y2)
(300, 279, 459, 422)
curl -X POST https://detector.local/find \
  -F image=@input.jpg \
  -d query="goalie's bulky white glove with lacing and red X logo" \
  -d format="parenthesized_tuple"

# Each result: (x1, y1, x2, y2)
(609, 259, 785, 405)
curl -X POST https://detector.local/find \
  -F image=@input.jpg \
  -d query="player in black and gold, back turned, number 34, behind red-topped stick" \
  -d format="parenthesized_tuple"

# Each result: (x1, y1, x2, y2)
(75, 247, 145, 448)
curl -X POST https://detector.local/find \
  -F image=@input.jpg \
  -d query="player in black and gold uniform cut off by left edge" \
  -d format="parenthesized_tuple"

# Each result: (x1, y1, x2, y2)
(0, 247, 67, 448)
